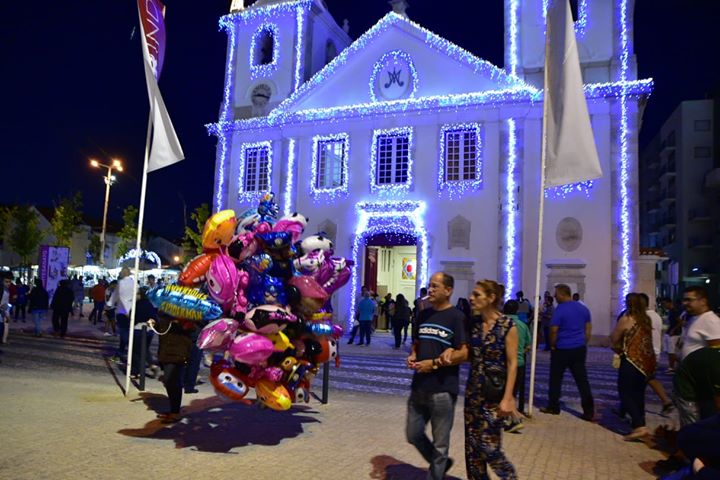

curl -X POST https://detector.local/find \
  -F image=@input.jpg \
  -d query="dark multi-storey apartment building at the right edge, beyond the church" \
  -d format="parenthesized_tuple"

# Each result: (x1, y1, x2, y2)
(640, 98, 720, 306)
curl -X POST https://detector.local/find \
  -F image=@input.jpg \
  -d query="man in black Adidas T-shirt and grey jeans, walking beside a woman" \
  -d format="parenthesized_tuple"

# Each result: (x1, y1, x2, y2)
(405, 272, 468, 480)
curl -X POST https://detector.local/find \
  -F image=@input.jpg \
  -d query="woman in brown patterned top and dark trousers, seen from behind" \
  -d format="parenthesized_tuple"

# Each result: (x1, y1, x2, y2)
(610, 293, 656, 441)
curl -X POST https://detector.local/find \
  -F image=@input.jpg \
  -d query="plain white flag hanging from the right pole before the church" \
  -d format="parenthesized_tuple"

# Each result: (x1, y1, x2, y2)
(544, 0, 602, 188)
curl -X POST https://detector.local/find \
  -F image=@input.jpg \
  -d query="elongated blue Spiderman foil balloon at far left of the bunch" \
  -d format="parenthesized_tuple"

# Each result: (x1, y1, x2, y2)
(147, 285, 222, 321)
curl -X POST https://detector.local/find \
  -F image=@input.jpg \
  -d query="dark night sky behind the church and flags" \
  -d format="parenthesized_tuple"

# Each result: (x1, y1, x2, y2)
(0, 0, 720, 238)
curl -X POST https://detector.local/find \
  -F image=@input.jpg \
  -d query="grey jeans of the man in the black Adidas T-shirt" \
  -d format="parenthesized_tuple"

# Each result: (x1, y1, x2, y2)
(405, 391, 457, 480)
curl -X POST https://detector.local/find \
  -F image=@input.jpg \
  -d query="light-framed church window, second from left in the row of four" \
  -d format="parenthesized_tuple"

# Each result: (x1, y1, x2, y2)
(312, 133, 348, 193)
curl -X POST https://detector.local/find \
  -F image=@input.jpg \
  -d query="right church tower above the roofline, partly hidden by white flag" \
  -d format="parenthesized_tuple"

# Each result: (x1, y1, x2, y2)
(505, 0, 637, 88)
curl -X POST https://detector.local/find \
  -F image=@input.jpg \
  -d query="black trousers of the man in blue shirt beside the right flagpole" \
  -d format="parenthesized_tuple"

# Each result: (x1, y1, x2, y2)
(548, 347, 595, 415)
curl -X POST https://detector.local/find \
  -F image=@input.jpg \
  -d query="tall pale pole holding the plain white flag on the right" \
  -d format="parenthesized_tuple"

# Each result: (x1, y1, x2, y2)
(528, 22, 551, 416)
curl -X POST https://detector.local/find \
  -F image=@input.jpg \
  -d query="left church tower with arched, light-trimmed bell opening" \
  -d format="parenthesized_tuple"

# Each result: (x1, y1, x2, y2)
(220, 0, 350, 121)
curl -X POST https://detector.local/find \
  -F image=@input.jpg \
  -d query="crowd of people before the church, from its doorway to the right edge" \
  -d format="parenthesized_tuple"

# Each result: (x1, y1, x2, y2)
(348, 272, 720, 480)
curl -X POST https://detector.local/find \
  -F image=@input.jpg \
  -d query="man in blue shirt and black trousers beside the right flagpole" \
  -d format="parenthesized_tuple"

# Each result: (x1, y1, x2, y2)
(540, 284, 595, 421)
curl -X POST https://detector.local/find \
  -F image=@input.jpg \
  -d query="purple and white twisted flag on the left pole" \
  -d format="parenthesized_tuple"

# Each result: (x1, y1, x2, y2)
(138, 0, 185, 172)
